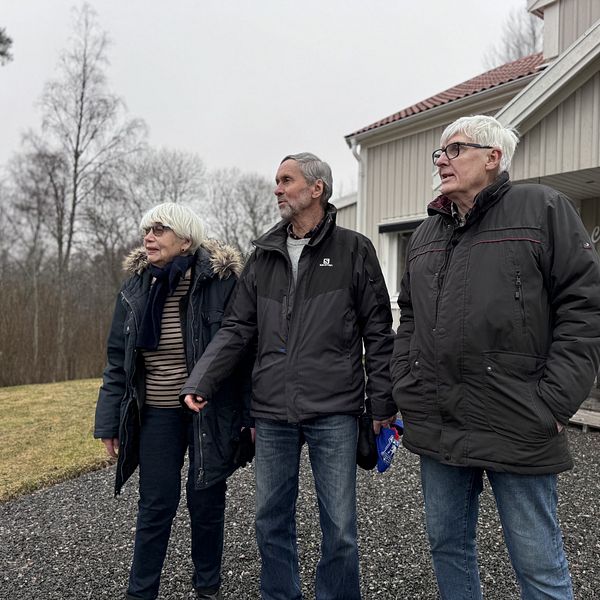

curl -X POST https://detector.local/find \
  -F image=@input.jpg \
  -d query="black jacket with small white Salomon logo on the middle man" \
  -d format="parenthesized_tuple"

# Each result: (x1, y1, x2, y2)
(181, 205, 396, 423)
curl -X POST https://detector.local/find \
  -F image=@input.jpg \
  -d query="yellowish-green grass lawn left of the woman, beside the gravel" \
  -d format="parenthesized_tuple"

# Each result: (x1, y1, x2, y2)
(0, 379, 109, 502)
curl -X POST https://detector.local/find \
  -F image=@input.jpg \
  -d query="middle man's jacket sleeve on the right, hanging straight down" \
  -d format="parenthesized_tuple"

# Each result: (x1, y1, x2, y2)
(355, 239, 396, 420)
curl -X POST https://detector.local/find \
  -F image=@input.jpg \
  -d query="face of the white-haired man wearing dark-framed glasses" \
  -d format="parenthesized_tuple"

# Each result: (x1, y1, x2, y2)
(436, 134, 500, 202)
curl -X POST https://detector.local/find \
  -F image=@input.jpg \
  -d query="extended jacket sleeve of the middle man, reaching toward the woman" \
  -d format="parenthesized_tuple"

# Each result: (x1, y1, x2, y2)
(180, 252, 256, 400)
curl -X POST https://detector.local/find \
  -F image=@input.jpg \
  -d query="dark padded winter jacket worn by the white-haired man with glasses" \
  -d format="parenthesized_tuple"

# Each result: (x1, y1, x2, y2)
(392, 173, 600, 474)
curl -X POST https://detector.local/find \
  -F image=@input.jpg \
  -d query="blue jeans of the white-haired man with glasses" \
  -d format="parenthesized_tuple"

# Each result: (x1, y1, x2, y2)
(421, 456, 573, 600)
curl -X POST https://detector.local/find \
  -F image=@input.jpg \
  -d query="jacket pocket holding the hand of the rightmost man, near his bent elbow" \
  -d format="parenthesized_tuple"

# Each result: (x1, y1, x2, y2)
(483, 352, 557, 441)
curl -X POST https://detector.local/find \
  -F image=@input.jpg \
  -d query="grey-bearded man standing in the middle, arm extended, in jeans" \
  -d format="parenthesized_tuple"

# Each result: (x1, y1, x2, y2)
(181, 153, 396, 600)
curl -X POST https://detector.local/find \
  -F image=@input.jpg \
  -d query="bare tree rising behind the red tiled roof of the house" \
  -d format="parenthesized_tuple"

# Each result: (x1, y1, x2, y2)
(483, 7, 544, 69)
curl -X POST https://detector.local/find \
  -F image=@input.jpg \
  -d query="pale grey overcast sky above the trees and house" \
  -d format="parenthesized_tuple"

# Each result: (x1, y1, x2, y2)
(0, 0, 525, 196)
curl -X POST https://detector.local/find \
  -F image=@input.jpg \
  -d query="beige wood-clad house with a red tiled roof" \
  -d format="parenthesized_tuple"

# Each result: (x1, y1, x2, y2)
(339, 0, 600, 318)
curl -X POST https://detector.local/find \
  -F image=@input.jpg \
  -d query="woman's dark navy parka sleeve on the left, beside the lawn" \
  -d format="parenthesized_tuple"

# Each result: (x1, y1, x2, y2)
(94, 294, 126, 438)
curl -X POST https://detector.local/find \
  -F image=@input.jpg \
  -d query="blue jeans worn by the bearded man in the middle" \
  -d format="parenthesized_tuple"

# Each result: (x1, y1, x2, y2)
(255, 415, 360, 600)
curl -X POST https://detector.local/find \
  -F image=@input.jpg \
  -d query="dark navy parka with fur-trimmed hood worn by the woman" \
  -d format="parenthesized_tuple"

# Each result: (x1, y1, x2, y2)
(94, 241, 250, 494)
